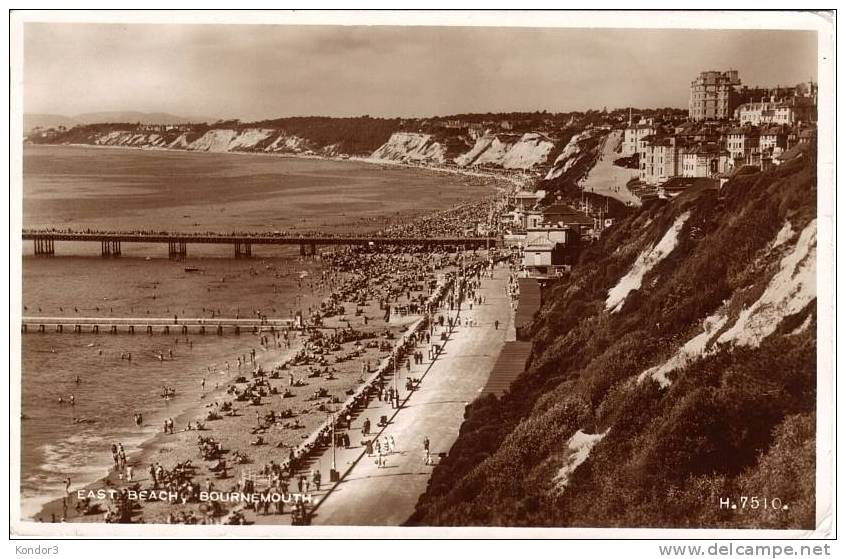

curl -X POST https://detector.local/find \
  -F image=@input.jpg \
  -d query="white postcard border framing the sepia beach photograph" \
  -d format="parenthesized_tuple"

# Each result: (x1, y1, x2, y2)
(8, 11, 836, 539)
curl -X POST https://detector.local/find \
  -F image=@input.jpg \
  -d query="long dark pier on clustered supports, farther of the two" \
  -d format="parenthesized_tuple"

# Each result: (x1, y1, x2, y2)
(21, 230, 501, 260)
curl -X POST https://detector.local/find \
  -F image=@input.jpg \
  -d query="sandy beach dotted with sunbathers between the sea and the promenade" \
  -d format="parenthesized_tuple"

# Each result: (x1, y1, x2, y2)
(31, 245, 505, 523)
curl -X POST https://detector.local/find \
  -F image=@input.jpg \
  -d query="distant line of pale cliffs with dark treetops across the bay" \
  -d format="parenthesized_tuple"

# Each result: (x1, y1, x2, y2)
(27, 117, 596, 176)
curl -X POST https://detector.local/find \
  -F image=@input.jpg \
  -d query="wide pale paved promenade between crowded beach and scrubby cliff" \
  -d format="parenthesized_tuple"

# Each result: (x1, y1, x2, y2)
(312, 266, 513, 526)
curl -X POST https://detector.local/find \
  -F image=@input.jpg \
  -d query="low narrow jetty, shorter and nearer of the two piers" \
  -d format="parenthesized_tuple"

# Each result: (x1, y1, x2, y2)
(21, 316, 297, 336)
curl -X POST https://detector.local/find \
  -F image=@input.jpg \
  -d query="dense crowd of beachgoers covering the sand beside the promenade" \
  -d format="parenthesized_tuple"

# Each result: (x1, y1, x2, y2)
(43, 190, 516, 524)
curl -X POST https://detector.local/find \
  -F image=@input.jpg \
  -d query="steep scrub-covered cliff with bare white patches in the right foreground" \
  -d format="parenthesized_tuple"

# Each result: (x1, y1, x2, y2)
(408, 155, 817, 529)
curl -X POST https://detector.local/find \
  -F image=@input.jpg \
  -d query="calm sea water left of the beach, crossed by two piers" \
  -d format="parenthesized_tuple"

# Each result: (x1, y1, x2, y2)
(21, 146, 490, 517)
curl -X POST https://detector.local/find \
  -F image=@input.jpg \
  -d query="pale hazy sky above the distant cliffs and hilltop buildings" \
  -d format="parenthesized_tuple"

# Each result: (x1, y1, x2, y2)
(23, 23, 817, 121)
